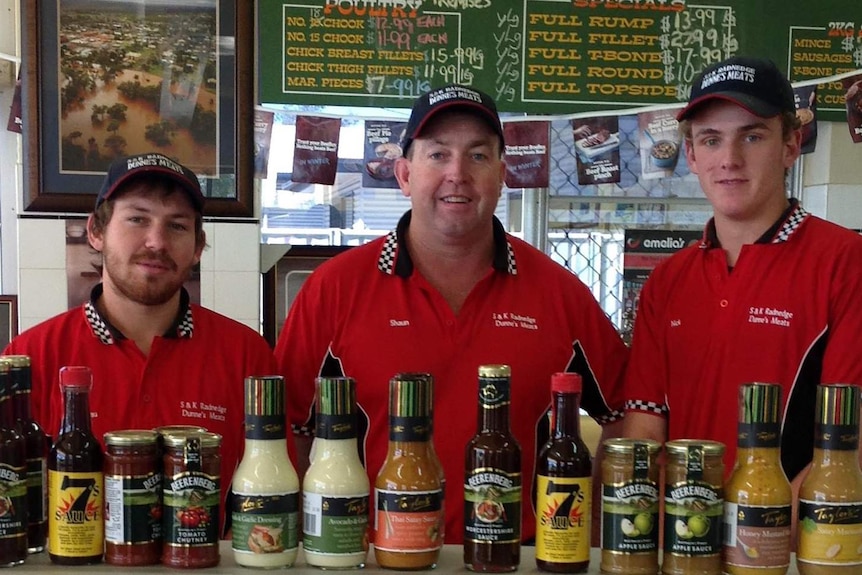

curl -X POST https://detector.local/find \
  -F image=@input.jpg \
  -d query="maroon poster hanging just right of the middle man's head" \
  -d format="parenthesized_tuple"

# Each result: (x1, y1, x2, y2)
(503, 121, 551, 188)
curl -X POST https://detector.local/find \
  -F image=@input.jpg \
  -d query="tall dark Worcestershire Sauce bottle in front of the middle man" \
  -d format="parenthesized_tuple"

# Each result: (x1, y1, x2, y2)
(464, 365, 522, 573)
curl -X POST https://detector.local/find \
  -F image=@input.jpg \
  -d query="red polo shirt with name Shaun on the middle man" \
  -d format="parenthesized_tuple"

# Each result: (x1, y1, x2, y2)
(276, 212, 627, 543)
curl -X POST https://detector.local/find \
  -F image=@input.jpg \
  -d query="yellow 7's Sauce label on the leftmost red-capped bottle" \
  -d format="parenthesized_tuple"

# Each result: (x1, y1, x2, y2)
(48, 471, 105, 557)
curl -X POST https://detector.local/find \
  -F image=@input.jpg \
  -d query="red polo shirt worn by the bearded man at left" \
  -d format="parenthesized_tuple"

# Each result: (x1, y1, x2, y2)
(4, 285, 275, 536)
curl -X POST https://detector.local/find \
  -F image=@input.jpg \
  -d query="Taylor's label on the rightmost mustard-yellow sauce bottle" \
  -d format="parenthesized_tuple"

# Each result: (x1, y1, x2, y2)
(796, 500, 862, 565)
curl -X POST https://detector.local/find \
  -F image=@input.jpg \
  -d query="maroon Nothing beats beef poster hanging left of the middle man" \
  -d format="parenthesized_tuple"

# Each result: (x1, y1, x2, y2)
(291, 116, 341, 185)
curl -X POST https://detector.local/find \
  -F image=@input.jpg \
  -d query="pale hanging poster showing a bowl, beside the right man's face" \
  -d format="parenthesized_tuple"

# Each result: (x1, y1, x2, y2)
(638, 110, 681, 180)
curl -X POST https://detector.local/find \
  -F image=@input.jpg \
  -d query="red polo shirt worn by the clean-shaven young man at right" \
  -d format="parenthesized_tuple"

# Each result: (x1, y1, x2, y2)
(626, 201, 862, 479)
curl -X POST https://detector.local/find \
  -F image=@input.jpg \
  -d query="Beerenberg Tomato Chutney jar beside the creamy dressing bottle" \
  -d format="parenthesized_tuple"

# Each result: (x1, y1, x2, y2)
(162, 432, 221, 568)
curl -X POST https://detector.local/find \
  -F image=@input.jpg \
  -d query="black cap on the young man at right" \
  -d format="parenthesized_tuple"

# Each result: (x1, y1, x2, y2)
(676, 56, 796, 121)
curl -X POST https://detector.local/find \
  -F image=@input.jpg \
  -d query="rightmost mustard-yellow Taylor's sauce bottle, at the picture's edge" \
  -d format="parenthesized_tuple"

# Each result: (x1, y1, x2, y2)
(796, 385, 862, 575)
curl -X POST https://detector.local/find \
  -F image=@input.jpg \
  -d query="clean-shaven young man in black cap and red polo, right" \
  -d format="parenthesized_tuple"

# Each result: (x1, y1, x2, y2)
(624, 57, 862, 502)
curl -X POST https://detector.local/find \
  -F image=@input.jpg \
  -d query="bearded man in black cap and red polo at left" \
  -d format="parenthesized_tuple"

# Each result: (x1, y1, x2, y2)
(4, 153, 275, 536)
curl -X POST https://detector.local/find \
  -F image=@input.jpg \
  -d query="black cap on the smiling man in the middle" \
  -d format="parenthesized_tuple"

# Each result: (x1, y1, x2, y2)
(401, 84, 503, 156)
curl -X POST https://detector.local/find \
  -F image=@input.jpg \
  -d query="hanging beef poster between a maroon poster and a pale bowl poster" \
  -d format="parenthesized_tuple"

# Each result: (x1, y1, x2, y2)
(572, 116, 620, 186)
